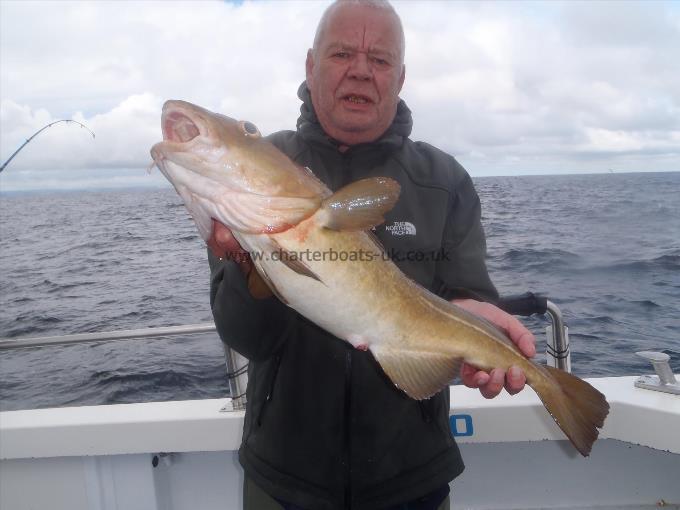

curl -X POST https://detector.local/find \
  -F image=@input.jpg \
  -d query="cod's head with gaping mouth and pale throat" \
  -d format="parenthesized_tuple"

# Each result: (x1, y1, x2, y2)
(151, 100, 329, 240)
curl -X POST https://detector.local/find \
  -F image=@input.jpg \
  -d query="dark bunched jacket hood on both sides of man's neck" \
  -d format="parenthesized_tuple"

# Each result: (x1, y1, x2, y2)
(297, 81, 413, 148)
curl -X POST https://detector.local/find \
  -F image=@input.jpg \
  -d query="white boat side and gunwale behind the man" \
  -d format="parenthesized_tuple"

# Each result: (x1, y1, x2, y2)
(0, 377, 680, 510)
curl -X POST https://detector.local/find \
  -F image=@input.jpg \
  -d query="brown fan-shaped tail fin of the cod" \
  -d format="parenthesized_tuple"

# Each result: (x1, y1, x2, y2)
(532, 366, 609, 457)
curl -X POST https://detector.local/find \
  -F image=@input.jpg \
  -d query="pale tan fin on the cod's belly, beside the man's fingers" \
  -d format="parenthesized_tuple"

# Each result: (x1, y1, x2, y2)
(371, 346, 463, 400)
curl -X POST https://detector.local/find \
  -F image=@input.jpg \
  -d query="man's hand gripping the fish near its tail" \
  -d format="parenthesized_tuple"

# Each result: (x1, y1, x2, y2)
(453, 299, 536, 398)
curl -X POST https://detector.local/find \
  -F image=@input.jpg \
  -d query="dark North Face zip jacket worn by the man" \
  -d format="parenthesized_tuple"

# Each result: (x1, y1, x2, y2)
(209, 83, 497, 510)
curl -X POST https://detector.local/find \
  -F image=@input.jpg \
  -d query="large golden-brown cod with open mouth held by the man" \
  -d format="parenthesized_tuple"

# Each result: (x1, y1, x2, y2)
(151, 101, 609, 456)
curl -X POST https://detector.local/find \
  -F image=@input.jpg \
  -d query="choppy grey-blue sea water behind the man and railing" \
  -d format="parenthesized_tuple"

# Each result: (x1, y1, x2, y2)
(0, 172, 680, 410)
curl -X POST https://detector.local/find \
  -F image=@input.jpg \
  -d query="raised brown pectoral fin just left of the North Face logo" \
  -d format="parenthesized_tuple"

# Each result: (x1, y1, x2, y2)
(321, 177, 401, 230)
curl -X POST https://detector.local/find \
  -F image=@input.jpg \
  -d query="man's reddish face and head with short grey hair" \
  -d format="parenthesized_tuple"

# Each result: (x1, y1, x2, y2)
(306, 4, 404, 145)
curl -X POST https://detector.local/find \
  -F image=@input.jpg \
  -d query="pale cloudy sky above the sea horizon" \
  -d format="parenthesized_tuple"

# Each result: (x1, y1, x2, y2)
(0, 0, 680, 191)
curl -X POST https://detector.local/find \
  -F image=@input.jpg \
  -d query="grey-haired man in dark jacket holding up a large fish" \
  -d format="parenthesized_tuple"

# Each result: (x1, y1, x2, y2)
(208, 0, 535, 510)
